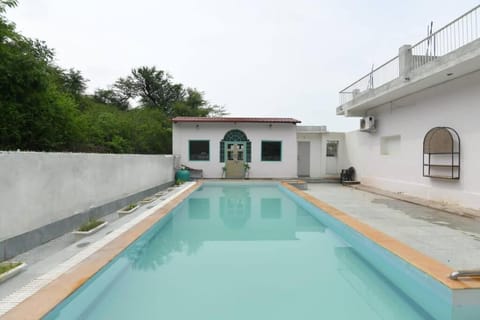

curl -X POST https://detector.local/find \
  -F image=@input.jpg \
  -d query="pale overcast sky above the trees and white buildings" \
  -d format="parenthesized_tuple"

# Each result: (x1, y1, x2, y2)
(7, 0, 478, 131)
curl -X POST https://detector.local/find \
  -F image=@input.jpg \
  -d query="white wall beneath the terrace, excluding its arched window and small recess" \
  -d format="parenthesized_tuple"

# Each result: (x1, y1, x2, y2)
(346, 72, 480, 209)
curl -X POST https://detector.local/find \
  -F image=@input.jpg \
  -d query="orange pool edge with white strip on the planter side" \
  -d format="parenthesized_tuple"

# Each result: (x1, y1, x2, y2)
(0, 181, 203, 320)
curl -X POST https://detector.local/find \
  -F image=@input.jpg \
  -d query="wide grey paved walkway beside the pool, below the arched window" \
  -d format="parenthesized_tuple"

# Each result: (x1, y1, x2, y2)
(307, 183, 480, 270)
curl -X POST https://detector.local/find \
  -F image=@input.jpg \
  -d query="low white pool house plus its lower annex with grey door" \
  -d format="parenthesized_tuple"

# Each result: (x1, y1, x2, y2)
(173, 117, 348, 179)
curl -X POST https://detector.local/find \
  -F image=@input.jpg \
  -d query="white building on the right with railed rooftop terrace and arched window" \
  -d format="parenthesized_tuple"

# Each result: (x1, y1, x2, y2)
(337, 7, 480, 209)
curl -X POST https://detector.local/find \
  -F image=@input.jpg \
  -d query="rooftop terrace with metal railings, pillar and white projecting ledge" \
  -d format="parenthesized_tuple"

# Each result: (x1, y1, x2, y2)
(336, 5, 480, 116)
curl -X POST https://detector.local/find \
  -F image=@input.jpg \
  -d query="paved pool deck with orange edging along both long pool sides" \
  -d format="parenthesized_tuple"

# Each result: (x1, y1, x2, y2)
(0, 183, 480, 319)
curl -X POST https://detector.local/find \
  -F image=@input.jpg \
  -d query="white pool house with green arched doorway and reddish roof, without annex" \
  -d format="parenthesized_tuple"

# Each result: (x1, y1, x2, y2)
(172, 117, 300, 178)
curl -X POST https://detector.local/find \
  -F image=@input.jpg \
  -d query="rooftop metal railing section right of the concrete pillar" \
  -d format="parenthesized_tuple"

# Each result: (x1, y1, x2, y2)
(411, 5, 480, 70)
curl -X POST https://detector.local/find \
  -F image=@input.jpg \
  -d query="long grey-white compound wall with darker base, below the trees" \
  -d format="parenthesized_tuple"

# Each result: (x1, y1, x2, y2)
(0, 152, 174, 261)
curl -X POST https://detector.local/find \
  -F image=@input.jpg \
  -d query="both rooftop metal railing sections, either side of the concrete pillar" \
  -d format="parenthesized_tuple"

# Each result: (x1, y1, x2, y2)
(339, 5, 480, 105)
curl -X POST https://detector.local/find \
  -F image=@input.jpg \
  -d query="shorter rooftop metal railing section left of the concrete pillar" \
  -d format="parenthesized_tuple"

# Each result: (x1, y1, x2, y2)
(340, 56, 399, 104)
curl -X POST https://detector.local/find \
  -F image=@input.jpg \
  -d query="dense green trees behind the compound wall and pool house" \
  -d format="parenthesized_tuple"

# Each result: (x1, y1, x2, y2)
(0, 0, 226, 154)
